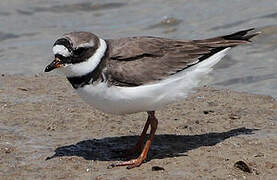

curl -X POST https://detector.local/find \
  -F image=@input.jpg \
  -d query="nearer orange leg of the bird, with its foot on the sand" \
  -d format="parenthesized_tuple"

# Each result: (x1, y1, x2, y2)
(111, 111, 158, 169)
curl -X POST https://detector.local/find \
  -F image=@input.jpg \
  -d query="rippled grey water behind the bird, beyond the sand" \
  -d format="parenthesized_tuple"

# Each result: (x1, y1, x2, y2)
(0, 0, 277, 98)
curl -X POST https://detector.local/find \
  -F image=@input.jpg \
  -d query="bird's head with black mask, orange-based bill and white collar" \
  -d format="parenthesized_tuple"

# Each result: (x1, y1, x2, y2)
(44, 32, 106, 77)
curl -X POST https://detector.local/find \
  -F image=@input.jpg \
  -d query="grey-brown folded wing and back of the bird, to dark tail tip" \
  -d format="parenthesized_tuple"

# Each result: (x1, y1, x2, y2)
(106, 29, 258, 86)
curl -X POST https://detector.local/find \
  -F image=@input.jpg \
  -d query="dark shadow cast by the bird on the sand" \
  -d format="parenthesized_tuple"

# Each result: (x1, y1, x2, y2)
(46, 127, 258, 161)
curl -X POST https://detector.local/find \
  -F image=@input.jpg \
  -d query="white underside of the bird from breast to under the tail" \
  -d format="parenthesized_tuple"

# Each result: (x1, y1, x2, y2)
(74, 48, 229, 114)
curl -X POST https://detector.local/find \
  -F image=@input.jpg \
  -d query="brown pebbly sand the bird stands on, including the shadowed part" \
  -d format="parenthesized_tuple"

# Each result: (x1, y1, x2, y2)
(0, 75, 277, 180)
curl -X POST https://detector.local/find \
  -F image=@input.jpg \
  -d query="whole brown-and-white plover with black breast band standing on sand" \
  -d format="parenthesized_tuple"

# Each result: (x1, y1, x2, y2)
(44, 28, 260, 169)
